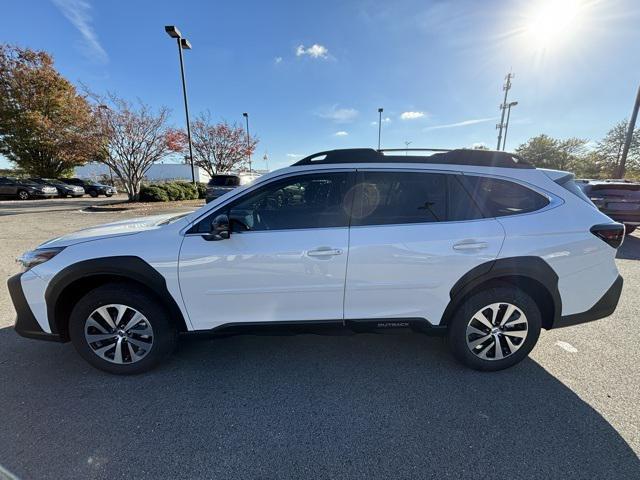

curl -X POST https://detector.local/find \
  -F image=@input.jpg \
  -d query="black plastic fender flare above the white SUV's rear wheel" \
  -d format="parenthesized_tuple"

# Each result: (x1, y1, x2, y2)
(441, 256, 562, 325)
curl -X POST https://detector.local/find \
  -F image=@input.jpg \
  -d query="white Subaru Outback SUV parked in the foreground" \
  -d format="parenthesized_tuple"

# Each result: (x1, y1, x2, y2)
(9, 149, 624, 373)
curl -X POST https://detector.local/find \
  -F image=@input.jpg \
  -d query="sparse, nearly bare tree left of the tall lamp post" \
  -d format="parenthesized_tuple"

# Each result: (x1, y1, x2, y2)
(93, 94, 177, 201)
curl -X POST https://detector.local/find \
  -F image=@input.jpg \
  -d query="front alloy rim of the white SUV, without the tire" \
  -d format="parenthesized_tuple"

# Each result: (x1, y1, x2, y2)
(84, 304, 153, 364)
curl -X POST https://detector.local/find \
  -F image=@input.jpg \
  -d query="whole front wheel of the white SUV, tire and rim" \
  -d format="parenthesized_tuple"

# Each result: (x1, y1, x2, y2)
(69, 284, 177, 374)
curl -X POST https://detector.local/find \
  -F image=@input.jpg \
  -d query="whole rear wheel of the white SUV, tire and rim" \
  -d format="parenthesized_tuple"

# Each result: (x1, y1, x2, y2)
(449, 286, 542, 371)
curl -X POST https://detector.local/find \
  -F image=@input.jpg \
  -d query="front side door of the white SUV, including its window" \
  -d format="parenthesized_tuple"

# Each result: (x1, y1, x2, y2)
(179, 170, 355, 329)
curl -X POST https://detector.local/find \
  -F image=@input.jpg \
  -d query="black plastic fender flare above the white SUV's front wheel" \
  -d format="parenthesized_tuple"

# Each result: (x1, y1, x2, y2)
(44, 256, 186, 334)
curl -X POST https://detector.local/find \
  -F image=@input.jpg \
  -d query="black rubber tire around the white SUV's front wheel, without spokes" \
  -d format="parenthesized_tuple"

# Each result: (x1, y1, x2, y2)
(69, 283, 178, 375)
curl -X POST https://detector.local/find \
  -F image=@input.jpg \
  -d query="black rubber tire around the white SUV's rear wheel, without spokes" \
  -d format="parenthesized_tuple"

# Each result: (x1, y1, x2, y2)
(448, 286, 542, 371)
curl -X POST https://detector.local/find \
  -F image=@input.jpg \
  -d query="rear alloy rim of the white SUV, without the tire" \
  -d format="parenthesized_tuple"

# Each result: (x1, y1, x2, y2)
(466, 302, 529, 360)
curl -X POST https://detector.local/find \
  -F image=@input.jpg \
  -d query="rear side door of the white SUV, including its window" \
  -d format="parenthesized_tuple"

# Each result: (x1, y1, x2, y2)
(345, 170, 504, 324)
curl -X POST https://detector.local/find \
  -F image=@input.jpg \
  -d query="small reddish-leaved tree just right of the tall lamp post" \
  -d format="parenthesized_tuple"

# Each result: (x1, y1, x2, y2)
(172, 112, 258, 175)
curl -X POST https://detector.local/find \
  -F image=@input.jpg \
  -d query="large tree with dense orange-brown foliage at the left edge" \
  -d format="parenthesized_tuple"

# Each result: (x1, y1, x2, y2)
(0, 44, 100, 177)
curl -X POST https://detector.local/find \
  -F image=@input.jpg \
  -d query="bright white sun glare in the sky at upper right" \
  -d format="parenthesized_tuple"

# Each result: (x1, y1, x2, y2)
(525, 0, 583, 50)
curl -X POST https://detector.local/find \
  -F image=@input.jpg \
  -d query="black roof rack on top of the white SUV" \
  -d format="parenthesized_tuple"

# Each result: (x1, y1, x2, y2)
(293, 148, 535, 168)
